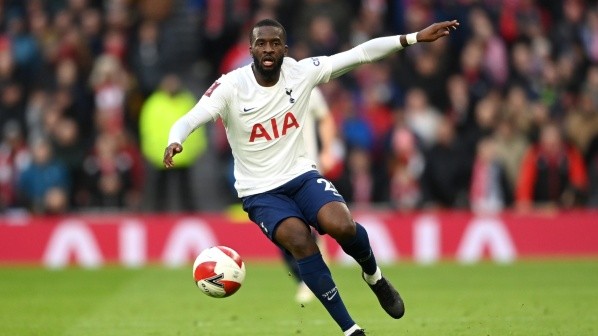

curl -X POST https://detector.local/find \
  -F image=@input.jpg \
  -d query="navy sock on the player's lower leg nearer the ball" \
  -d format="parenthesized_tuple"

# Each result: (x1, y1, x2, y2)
(297, 252, 355, 331)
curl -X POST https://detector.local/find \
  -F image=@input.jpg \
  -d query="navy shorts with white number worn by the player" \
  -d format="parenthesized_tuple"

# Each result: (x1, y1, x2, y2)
(243, 170, 345, 241)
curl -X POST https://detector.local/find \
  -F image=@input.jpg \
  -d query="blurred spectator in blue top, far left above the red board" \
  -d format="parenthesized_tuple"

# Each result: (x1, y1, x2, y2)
(18, 138, 70, 214)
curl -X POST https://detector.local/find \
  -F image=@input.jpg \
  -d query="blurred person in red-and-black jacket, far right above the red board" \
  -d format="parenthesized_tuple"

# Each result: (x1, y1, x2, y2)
(516, 123, 587, 211)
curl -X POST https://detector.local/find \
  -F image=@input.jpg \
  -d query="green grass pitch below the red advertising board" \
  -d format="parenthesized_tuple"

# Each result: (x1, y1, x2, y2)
(0, 260, 598, 336)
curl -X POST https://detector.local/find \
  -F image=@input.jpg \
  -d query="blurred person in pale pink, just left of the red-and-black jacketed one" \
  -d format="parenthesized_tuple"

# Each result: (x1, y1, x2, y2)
(469, 137, 513, 213)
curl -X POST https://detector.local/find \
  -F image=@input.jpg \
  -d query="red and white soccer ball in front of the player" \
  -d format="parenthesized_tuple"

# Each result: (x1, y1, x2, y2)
(193, 246, 245, 298)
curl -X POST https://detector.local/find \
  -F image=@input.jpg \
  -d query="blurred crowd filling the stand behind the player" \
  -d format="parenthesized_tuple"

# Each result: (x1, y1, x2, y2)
(0, 0, 598, 214)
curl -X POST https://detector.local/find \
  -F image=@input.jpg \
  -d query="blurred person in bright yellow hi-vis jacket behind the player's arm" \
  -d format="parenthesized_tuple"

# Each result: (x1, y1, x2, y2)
(139, 74, 206, 211)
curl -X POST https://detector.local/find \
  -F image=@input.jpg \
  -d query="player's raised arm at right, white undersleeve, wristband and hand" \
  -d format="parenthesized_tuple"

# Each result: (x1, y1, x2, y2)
(330, 20, 459, 78)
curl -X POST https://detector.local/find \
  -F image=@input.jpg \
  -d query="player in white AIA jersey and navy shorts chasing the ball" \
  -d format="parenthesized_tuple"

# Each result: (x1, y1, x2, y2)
(164, 19, 459, 336)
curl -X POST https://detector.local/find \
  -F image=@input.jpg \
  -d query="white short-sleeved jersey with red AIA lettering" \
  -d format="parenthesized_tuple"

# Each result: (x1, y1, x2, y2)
(197, 57, 331, 197)
